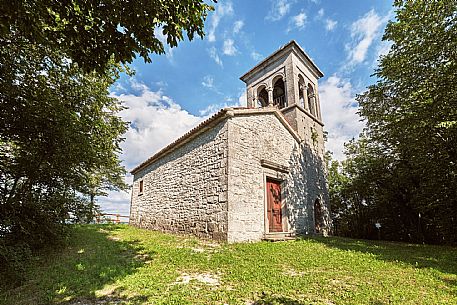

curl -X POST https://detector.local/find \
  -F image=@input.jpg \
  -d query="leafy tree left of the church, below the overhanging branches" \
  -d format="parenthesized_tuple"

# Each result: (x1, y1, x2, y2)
(0, 34, 126, 284)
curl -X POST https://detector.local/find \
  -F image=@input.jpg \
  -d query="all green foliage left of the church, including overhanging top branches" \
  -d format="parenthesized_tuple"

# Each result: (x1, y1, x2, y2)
(0, 0, 212, 283)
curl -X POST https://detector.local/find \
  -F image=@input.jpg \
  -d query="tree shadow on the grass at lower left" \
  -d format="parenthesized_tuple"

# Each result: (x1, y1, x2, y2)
(0, 225, 151, 304)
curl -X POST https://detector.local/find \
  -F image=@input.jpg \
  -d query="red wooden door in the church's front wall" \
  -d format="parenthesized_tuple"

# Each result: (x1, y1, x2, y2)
(267, 180, 282, 232)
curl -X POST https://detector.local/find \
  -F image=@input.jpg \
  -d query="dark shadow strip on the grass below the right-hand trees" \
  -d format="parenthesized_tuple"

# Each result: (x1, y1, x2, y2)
(312, 237, 457, 278)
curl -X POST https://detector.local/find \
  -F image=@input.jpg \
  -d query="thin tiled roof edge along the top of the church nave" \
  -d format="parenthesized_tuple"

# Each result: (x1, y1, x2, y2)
(130, 107, 301, 175)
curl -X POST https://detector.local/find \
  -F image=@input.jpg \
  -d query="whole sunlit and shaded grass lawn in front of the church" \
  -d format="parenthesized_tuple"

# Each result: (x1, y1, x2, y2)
(0, 225, 457, 305)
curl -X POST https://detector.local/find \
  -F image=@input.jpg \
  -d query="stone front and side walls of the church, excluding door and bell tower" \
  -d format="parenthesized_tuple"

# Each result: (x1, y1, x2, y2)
(130, 110, 329, 242)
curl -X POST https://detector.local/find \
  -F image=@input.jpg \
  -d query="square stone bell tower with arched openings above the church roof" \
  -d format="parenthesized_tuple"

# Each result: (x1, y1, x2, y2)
(240, 40, 324, 160)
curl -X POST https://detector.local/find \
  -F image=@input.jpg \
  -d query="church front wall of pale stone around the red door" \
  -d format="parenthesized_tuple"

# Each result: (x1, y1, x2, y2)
(228, 114, 314, 242)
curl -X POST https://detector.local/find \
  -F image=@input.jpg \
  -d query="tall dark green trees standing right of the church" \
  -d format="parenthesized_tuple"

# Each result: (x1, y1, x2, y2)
(348, 0, 457, 242)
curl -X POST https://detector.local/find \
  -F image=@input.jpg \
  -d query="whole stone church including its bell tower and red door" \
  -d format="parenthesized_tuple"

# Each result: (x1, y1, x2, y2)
(130, 41, 330, 242)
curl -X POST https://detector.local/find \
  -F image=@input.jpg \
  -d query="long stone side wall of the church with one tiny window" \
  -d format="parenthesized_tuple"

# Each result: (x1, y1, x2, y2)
(130, 120, 228, 240)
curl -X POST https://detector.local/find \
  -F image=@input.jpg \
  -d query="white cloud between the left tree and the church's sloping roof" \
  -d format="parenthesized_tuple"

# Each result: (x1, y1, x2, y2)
(98, 81, 206, 215)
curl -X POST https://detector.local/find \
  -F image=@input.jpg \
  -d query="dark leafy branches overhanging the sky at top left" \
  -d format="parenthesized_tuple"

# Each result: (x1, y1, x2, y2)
(0, 0, 212, 72)
